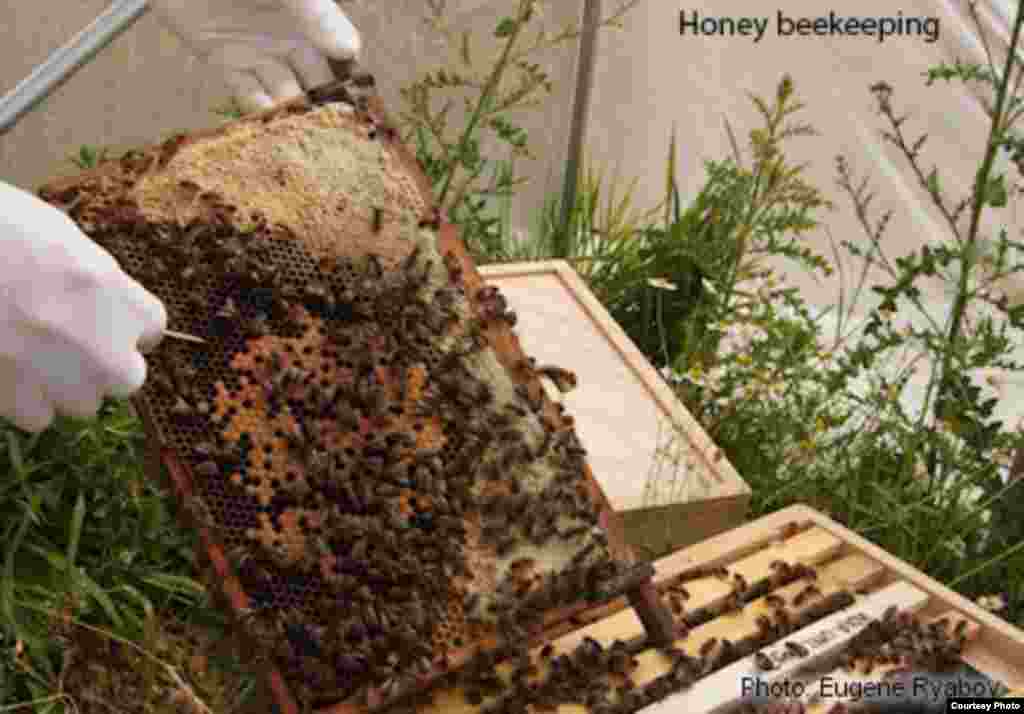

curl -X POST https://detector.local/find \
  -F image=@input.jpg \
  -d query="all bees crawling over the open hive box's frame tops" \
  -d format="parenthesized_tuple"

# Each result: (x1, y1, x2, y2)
(423, 561, 966, 714)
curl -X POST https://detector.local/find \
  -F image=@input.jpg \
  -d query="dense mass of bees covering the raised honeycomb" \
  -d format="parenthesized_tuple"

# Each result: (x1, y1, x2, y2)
(39, 118, 634, 705)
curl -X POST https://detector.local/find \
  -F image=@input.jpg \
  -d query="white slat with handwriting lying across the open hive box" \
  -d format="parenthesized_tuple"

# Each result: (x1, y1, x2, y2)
(645, 583, 928, 714)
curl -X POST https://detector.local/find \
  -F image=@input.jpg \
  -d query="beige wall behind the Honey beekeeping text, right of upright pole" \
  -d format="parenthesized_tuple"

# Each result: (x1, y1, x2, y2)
(588, 0, 1017, 311)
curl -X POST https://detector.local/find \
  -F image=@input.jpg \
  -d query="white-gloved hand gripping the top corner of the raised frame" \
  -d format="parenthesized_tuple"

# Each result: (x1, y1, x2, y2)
(152, 0, 361, 112)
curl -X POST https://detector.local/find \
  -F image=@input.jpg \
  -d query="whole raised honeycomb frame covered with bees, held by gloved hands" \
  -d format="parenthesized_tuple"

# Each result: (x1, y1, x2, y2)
(40, 69, 671, 714)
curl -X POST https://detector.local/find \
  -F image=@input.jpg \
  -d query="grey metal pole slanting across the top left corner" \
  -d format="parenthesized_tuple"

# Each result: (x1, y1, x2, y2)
(0, 0, 150, 136)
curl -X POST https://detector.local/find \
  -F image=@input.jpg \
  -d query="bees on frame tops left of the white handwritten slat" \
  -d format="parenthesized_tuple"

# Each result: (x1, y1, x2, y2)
(376, 560, 872, 714)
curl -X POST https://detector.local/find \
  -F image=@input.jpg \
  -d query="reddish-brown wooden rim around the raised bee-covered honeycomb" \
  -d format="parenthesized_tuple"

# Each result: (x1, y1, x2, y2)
(40, 72, 671, 714)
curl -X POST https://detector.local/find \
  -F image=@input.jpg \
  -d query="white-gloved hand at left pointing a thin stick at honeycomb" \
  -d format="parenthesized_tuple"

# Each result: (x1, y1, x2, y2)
(0, 182, 167, 431)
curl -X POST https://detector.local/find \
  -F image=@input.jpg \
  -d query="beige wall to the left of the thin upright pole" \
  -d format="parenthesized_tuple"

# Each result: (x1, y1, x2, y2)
(0, 0, 582, 239)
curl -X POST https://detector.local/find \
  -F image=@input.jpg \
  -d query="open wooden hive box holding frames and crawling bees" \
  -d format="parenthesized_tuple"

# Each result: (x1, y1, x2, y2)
(385, 505, 1024, 714)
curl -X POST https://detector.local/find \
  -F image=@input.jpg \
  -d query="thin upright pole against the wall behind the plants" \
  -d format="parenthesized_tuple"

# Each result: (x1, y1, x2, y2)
(555, 0, 601, 258)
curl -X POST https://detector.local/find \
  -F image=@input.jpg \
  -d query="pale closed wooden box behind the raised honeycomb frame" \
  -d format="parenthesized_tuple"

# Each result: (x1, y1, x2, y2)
(480, 260, 751, 554)
